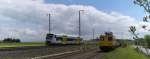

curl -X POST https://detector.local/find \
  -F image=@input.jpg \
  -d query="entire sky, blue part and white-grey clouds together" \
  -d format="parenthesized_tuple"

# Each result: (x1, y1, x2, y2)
(0, 0, 150, 42)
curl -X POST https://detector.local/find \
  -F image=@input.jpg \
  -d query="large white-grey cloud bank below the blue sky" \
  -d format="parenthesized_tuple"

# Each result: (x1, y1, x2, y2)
(0, 0, 143, 41)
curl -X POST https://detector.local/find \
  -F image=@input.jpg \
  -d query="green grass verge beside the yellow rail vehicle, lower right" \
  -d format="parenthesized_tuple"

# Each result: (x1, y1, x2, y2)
(102, 47, 150, 59)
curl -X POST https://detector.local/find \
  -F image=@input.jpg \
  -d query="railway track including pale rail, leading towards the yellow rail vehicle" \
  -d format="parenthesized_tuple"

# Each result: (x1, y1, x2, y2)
(31, 48, 104, 59)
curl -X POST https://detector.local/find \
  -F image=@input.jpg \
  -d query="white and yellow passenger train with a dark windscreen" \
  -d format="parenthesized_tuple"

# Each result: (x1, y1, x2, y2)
(46, 34, 83, 46)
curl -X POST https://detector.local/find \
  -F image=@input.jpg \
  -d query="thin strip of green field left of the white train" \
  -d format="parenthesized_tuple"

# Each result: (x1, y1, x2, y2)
(0, 42, 45, 48)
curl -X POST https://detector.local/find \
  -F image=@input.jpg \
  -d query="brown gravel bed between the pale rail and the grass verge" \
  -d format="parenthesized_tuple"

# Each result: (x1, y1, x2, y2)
(45, 49, 105, 59)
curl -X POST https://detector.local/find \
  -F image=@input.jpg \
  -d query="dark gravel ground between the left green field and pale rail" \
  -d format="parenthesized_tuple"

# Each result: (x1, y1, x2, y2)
(0, 46, 80, 59)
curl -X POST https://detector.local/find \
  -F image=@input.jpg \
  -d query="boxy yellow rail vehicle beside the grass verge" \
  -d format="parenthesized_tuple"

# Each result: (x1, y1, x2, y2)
(98, 32, 120, 51)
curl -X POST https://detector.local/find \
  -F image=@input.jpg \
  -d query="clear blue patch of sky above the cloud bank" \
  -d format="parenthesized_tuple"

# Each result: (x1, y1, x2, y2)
(45, 0, 145, 20)
